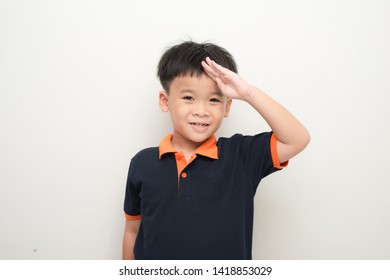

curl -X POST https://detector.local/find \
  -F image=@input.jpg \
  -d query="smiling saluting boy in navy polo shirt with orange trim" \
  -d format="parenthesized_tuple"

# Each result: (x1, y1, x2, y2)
(123, 42, 310, 259)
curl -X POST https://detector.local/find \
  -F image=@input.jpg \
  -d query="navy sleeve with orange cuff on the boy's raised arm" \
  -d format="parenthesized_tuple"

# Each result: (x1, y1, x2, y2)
(240, 132, 288, 186)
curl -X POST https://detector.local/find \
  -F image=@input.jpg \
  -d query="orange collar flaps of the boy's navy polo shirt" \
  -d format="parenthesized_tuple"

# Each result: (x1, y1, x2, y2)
(159, 134, 218, 159)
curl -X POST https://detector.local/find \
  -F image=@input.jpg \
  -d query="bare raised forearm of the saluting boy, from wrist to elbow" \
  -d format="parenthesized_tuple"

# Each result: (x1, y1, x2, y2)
(244, 86, 310, 160)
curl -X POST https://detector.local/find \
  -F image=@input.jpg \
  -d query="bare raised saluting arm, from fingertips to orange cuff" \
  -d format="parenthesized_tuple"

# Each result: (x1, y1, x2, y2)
(202, 58, 310, 162)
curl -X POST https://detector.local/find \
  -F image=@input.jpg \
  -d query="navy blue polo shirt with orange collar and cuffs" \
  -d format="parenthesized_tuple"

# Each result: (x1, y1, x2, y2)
(124, 132, 287, 260)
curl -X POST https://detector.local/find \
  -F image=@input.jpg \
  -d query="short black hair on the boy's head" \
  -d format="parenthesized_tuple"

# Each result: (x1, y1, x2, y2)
(157, 41, 237, 92)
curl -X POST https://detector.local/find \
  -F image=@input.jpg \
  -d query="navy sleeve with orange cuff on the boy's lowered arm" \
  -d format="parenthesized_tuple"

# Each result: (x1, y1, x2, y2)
(124, 161, 141, 220)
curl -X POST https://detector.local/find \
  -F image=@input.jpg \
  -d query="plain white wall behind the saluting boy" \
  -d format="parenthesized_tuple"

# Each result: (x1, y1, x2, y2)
(0, 0, 390, 259)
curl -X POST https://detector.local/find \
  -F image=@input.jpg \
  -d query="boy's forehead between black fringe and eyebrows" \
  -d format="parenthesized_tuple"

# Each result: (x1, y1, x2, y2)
(170, 74, 221, 94)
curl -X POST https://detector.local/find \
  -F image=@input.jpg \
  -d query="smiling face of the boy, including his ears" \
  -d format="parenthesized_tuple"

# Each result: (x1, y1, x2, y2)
(159, 74, 232, 148)
